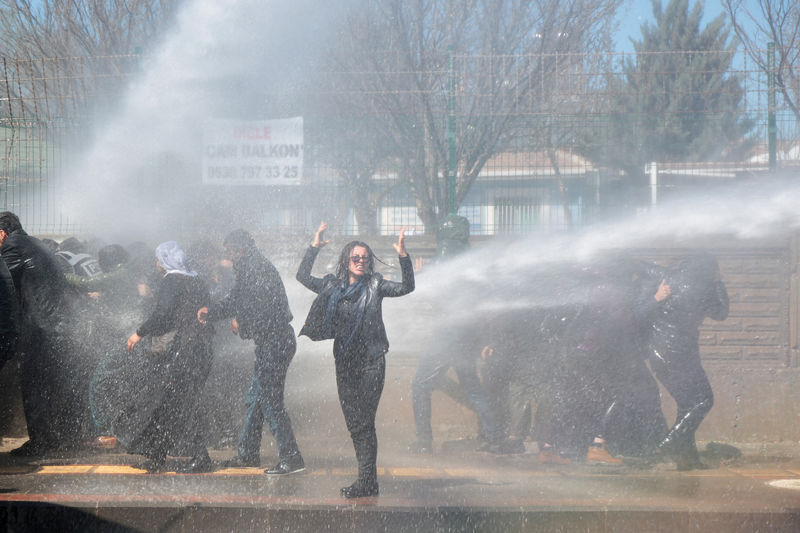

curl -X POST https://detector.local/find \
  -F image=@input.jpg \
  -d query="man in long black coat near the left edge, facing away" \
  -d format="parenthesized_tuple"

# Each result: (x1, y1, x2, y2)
(0, 211, 88, 456)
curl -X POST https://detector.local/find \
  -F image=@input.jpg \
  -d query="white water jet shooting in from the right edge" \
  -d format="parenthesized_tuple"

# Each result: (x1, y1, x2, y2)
(406, 172, 800, 336)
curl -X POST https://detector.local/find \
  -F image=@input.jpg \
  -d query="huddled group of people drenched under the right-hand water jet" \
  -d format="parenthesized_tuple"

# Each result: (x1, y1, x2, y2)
(409, 247, 729, 470)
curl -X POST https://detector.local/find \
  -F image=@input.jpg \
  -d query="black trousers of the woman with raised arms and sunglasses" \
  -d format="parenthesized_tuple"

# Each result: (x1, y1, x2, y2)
(336, 351, 386, 483)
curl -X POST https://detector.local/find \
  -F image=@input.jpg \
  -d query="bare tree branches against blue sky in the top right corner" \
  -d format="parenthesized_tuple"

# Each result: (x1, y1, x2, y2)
(722, 0, 800, 120)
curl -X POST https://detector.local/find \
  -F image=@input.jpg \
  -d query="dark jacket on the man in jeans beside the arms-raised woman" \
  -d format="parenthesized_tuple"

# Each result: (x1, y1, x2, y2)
(208, 248, 292, 342)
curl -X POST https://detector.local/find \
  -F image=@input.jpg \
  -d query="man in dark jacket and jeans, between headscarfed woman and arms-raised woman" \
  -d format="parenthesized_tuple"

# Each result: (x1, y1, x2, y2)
(197, 229, 305, 475)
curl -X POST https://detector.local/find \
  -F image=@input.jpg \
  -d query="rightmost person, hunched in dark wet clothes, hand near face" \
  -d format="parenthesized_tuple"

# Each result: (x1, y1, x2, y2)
(637, 253, 729, 470)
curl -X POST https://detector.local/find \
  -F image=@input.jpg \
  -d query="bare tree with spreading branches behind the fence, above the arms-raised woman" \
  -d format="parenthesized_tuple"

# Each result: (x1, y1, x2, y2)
(316, 0, 619, 232)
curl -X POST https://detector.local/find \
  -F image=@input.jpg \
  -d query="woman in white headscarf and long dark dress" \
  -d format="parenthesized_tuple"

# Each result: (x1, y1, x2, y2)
(109, 241, 214, 473)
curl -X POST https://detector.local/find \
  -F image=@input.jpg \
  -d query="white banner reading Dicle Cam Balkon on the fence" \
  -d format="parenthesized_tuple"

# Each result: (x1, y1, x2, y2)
(203, 117, 303, 185)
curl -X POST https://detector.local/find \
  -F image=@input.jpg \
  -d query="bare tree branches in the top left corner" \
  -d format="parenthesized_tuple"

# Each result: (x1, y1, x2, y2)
(0, 0, 180, 117)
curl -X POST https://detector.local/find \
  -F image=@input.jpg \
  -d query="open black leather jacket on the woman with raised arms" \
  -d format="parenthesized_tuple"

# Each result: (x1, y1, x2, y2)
(297, 246, 414, 355)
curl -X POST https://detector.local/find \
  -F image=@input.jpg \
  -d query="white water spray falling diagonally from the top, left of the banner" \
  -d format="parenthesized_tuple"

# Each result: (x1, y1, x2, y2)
(64, 0, 346, 238)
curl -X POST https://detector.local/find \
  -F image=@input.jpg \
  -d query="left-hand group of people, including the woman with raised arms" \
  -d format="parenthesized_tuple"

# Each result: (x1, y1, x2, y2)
(0, 211, 414, 498)
